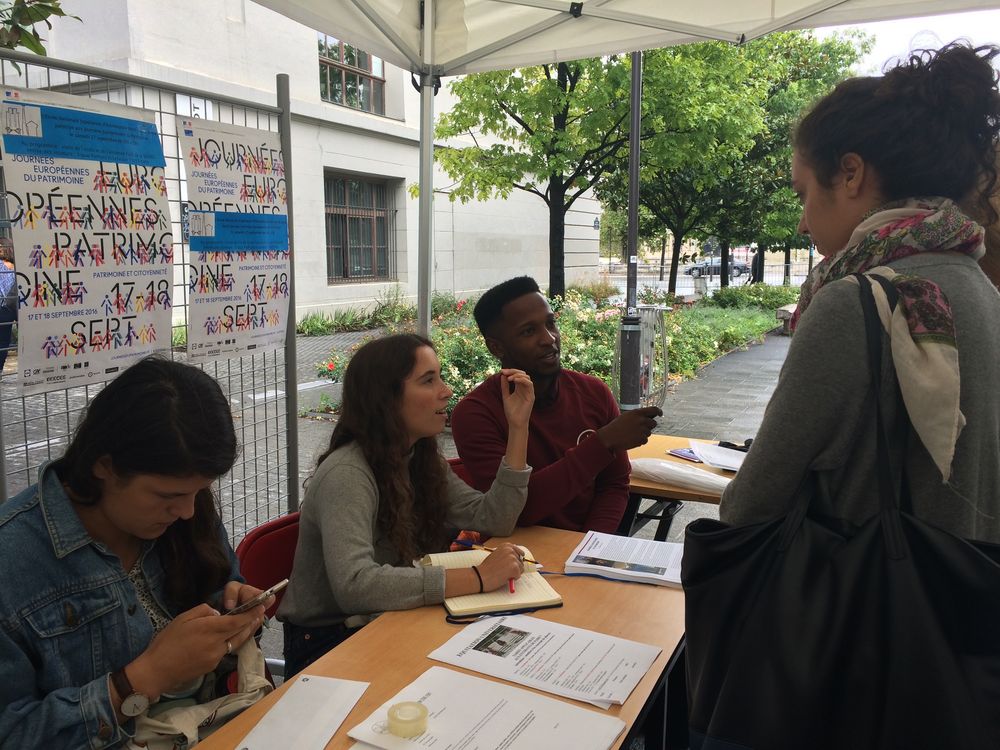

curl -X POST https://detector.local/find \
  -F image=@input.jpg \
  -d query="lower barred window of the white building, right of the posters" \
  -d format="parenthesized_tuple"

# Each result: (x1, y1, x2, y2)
(326, 174, 396, 284)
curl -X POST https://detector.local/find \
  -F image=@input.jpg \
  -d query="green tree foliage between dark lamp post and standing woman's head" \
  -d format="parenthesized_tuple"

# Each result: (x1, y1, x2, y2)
(597, 31, 865, 291)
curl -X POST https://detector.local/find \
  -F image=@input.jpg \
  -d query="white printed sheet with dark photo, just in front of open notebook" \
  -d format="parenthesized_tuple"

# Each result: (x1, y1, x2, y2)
(428, 615, 660, 708)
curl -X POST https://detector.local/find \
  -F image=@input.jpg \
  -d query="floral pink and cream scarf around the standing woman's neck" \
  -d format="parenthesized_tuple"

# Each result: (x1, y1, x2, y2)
(791, 198, 985, 481)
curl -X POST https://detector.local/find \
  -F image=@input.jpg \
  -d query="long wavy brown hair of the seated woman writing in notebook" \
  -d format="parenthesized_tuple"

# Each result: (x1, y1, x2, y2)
(317, 334, 449, 560)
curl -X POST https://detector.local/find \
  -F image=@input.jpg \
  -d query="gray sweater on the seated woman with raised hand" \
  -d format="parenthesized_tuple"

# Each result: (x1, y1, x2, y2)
(278, 443, 531, 627)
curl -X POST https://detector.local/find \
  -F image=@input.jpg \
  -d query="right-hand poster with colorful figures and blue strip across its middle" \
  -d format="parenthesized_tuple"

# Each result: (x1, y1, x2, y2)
(177, 117, 290, 361)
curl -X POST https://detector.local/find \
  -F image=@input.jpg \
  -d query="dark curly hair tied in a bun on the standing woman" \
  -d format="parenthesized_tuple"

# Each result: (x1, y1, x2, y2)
(794, 42, 1000, 222)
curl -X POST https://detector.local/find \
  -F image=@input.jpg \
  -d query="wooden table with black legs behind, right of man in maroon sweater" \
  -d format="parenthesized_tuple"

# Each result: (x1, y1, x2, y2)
(619, 435, 733, 541)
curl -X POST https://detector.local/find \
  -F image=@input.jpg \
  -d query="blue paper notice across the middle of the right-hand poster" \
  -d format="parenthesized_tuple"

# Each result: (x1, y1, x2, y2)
(188, 211, 288, 253)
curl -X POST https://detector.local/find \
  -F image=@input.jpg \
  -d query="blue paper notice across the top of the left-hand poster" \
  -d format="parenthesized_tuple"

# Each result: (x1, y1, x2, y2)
(0, 99, 166, 167)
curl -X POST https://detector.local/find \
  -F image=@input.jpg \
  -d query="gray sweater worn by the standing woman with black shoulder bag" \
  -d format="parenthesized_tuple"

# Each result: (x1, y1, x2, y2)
(719, 253, 1000, 542)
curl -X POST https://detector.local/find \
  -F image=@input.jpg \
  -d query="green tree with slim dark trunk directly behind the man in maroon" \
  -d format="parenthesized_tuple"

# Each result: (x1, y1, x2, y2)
(436, 56, 629, 295)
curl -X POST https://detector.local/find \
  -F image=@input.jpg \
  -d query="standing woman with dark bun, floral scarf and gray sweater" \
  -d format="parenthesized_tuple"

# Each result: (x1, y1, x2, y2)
(720, 43, 1000, 542)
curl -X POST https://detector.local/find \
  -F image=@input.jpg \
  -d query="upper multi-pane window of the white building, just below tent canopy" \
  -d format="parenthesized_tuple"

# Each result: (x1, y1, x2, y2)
(318, 33, 385, 115)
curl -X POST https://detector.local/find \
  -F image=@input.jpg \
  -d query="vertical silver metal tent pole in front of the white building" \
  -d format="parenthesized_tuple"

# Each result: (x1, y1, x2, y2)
(417, 0, 435, 336)
